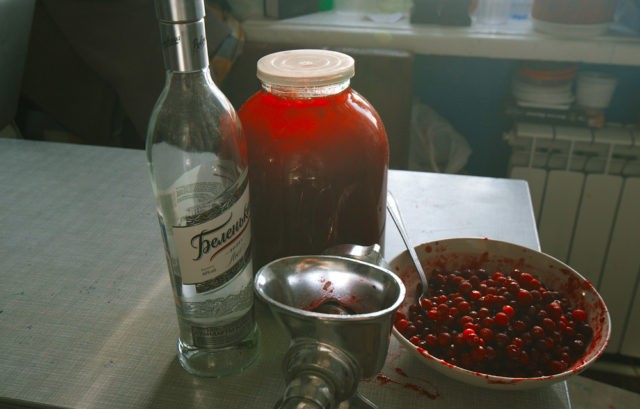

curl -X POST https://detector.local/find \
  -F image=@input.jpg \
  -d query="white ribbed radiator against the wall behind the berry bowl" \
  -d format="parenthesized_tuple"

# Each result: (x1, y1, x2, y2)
(505, 123, 640, 357)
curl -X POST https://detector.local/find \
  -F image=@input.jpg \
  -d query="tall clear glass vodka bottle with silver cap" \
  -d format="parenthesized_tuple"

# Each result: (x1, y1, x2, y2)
(146, 0, 259, 377)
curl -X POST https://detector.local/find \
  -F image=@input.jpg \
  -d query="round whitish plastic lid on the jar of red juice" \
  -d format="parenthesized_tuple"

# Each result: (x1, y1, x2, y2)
(257, 49, 355, 87)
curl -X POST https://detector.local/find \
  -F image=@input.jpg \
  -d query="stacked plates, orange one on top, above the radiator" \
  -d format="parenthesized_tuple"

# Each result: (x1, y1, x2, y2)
(512, 63, 576, 110)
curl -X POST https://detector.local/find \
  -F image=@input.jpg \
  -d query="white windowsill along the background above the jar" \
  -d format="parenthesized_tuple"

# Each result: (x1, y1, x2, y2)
(243, 11, 640, 66)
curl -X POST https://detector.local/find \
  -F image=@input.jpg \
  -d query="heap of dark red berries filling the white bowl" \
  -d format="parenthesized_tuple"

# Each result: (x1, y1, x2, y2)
(394, 269, 593, 378)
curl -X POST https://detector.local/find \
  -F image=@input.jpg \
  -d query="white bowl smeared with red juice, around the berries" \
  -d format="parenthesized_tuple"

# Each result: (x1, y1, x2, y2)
(390, 238, 611, 390)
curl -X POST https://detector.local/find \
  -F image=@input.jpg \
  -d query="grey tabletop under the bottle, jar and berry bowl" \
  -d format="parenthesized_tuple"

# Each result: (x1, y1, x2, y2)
(0, 139, 571, 409)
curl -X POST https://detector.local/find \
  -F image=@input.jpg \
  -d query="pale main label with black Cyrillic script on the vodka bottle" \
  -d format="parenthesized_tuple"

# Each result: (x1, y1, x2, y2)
(173, 184, 251, 284)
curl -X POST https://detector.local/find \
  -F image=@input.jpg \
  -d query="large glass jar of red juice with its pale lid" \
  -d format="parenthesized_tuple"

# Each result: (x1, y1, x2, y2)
(238, 50, 389, 269)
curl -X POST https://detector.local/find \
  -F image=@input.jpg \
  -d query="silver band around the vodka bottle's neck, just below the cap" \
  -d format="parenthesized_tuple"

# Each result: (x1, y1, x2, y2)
(160, 19, 209, 72)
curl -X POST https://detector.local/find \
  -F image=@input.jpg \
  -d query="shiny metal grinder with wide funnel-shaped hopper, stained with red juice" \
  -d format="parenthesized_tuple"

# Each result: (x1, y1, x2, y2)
(255, 255, 405, 408)
